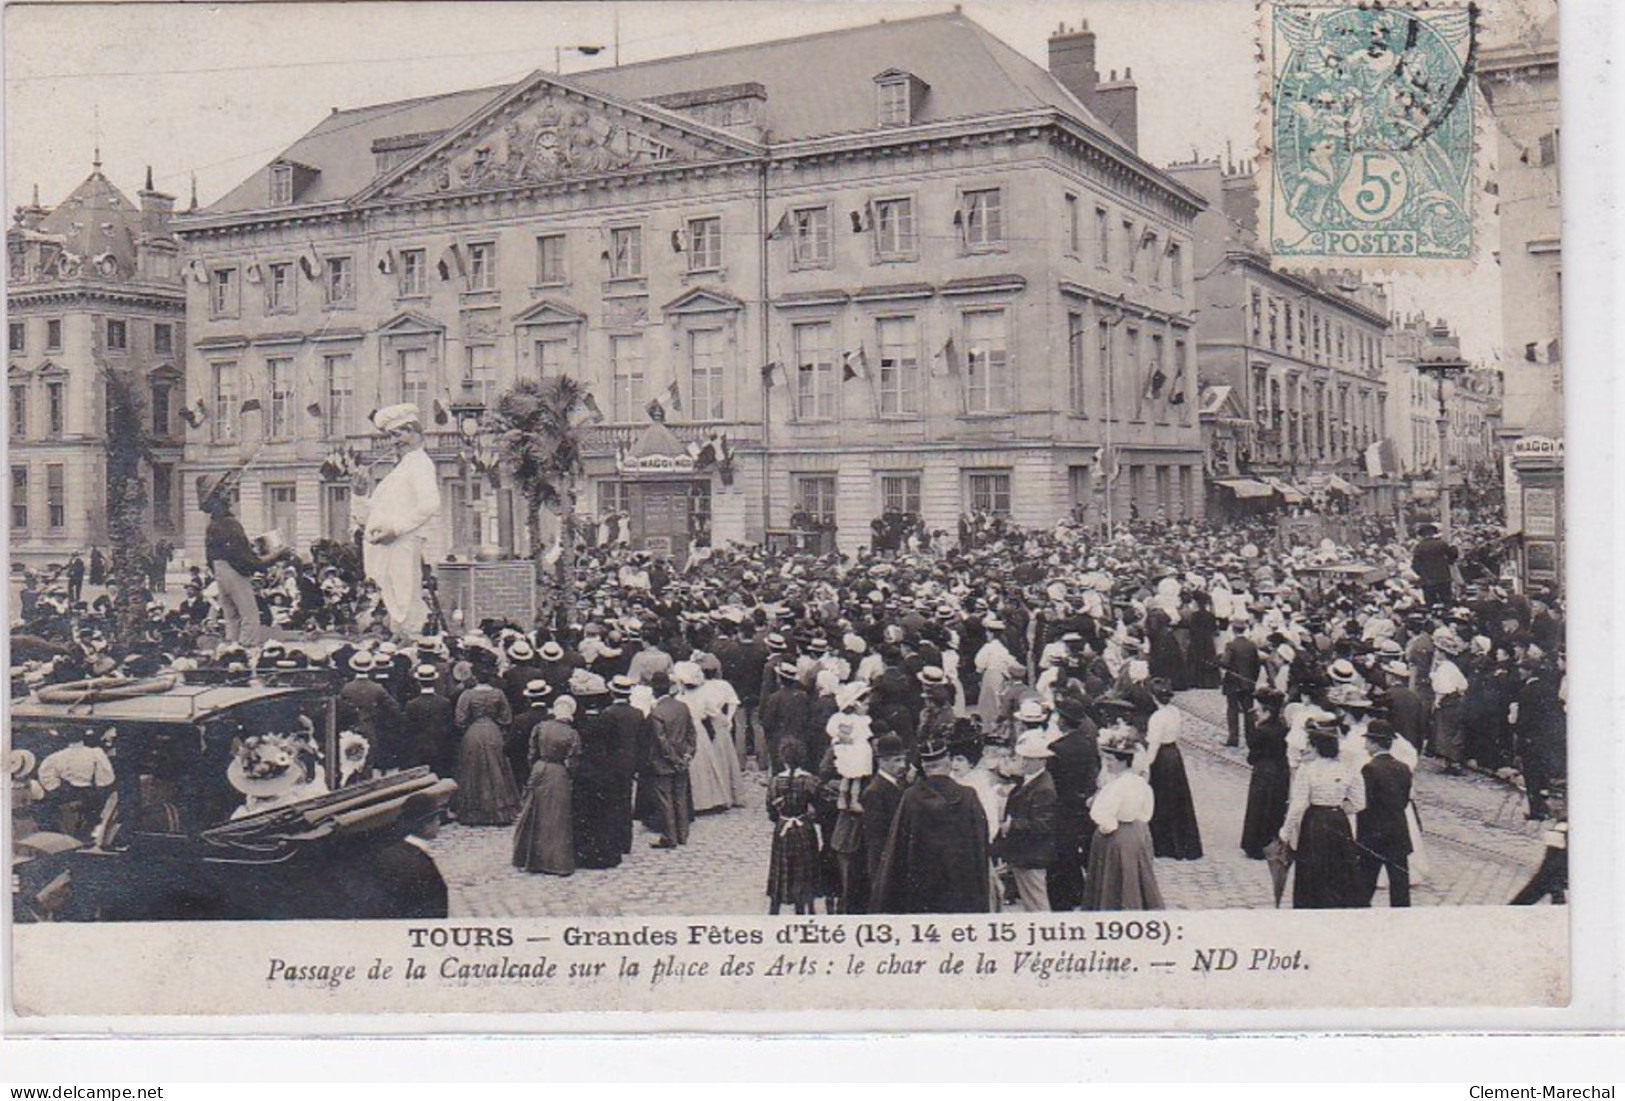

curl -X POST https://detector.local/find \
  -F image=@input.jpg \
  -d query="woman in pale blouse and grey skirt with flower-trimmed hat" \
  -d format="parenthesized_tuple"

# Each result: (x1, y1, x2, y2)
(1084, 724, 1164, 909)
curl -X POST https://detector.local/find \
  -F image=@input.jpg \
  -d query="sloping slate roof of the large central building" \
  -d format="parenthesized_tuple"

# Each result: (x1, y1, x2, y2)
(202, 11, 1133, 214)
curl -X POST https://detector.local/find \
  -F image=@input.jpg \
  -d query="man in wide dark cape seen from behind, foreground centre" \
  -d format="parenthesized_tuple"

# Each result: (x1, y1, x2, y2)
(869, 742, 993, 914)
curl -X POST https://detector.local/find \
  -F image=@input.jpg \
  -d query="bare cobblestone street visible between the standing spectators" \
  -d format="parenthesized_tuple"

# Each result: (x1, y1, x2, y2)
(434, 692, 1542, 918)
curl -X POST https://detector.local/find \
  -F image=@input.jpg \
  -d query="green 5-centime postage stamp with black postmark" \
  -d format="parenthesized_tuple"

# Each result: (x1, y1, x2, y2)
(1263, 3, 1477, 266)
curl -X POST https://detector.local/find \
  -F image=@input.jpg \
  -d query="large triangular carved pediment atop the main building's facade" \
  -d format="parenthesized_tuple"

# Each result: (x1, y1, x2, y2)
(353, 71, 757, 203)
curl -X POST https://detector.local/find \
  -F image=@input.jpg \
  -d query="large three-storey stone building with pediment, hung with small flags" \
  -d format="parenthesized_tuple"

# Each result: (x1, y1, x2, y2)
(180, 13, 1203, 568)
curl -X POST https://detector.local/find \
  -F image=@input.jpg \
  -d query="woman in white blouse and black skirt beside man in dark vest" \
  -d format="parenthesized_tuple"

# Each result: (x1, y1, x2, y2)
(1281, 719, 1365, 909)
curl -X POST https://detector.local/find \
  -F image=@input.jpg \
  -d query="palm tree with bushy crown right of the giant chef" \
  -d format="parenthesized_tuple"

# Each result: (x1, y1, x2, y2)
(491, 375, 592, 627)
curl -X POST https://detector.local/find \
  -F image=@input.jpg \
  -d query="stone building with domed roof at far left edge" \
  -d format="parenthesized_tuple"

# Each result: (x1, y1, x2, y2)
(7, 170, 187, 578)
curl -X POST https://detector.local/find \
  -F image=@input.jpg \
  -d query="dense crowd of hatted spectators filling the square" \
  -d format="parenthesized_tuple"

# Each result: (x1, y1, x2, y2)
(13, 493, 1567, 913)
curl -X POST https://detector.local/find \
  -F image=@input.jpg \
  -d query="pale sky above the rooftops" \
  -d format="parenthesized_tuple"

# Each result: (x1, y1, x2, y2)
(3, 0, 1552, 357)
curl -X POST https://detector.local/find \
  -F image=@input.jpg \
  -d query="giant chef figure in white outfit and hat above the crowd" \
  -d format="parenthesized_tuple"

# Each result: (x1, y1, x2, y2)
(353, 404, 440, 638)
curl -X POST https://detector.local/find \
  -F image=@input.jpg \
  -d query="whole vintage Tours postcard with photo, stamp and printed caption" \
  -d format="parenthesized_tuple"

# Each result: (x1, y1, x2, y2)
(5, 0, 1573, 1031)
